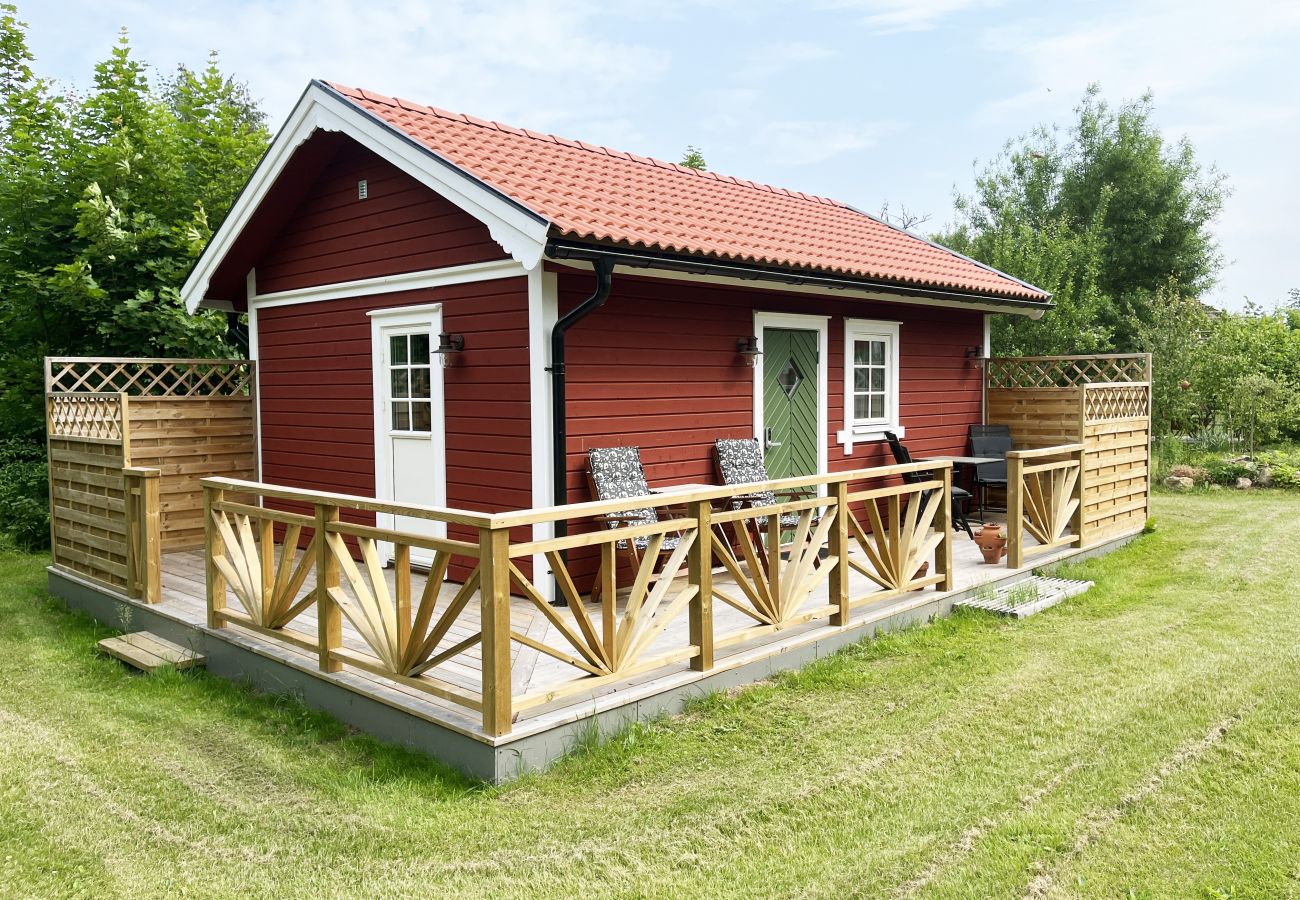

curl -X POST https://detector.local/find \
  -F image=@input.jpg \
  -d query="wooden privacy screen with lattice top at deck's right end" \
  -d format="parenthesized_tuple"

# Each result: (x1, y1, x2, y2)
(985, 354, 1151, 544)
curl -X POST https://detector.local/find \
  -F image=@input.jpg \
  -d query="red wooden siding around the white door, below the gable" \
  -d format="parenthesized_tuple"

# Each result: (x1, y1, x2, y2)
(257, 277, 532, 567)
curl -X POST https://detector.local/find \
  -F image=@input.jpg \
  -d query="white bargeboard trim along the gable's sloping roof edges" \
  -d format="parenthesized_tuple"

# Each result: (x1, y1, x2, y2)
(181, 82, 550, 312)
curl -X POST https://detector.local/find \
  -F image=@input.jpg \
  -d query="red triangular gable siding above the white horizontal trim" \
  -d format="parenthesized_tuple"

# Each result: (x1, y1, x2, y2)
(256, 138, 506, 294)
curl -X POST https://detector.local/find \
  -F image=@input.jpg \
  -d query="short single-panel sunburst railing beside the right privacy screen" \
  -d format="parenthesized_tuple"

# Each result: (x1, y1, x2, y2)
(1006, 443, 1084, 568)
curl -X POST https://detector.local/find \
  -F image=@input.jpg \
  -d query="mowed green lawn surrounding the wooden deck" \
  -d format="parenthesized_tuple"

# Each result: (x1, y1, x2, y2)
(0, 493, 1300, 897)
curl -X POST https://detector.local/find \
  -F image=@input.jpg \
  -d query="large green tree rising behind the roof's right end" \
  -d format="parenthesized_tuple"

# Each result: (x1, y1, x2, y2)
(937, 85, 1227, 352)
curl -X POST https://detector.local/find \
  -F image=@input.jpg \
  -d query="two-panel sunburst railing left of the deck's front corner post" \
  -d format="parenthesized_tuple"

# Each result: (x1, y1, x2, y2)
(203, 479, 493, 724)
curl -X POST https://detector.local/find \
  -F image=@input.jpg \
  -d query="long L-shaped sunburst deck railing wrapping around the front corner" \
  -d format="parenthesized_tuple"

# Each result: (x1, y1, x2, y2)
(203, 463, 954, 735)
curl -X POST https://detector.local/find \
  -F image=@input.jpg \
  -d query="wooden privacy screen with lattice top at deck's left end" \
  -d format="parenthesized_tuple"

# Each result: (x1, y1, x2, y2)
(46, 358, 257, 588)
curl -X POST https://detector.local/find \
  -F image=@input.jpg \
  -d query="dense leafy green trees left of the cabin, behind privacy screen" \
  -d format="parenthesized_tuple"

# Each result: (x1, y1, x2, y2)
(0, 5, 269, 436)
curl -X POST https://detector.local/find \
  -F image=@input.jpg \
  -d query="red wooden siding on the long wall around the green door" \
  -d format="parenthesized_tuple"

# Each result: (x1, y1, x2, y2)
(558, 272, 984, 587)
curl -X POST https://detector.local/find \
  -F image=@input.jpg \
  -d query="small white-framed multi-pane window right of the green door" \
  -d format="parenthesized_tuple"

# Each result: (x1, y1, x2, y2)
(844, 319, 902, 443)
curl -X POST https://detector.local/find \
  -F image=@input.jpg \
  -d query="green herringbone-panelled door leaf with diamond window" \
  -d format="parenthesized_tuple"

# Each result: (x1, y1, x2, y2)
(762, 328, 822, 479)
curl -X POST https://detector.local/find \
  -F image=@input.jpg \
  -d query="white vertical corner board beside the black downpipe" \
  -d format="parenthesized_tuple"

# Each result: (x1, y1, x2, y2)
(528, 267, 559, 602)
